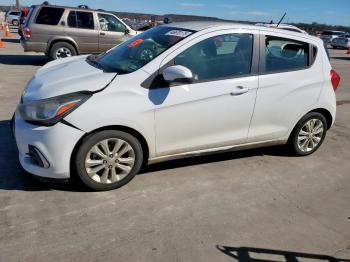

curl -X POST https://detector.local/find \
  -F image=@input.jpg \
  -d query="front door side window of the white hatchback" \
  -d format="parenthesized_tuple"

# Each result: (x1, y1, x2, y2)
(175, 34, 253, 81)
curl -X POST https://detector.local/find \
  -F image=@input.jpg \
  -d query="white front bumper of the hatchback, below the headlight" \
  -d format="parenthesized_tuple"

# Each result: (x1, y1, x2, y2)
(12, 112, 85, 179)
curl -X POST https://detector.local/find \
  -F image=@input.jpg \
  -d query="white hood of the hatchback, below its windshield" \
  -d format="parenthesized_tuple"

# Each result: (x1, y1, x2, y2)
(22, 55, 116, 102)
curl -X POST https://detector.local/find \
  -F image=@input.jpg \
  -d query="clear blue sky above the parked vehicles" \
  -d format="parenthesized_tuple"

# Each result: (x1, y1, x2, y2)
(0, 0, 350, 26)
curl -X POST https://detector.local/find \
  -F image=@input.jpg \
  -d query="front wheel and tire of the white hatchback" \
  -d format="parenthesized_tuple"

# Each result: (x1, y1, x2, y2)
(74, 130, 143, 191)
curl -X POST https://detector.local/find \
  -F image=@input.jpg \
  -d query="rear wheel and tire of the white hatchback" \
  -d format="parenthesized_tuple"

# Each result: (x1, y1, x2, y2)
(288, 112, 328, 156)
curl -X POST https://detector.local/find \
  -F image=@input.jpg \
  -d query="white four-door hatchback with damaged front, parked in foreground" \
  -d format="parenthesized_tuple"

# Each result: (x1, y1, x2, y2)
(13, 22, 340, 190)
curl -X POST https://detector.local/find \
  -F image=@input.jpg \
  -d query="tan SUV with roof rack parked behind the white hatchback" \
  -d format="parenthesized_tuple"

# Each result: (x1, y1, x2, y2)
(21, 5, 137, 60)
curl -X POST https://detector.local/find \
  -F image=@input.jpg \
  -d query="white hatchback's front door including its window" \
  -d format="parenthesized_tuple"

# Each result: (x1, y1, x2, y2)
(155, 32, 258, 156)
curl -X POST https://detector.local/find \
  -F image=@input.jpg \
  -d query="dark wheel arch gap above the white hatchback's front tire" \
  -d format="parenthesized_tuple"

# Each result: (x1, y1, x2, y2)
(70, 125, 149, 176)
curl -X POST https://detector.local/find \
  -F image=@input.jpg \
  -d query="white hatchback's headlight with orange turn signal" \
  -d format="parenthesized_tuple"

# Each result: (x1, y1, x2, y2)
(18, 92, 92, 126)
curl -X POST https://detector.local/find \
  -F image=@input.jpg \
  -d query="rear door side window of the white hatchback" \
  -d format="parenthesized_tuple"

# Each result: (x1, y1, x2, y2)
(265, 36, 309, 72)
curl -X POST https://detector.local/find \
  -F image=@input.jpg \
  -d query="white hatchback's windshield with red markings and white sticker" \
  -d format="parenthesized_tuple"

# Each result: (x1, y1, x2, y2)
(94, 26, 195, 74)
